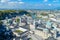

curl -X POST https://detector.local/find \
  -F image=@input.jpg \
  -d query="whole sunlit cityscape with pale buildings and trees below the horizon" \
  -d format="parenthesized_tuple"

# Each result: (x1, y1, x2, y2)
(0, 10, 60, 40)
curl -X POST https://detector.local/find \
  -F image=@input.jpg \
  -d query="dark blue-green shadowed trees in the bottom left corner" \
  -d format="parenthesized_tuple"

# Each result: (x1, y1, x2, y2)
(0, 22, 13, 40)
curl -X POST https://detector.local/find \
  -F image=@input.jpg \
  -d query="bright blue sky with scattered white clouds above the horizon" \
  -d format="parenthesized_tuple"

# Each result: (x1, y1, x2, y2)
(0, 0, 60, 9)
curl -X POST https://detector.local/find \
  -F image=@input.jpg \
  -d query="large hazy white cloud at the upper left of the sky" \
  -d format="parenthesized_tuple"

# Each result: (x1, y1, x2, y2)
(0, 0, 24, 8)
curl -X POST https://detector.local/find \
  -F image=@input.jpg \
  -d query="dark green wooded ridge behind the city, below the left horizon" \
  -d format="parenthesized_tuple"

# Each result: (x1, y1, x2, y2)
(0, 10, 30, 20)
